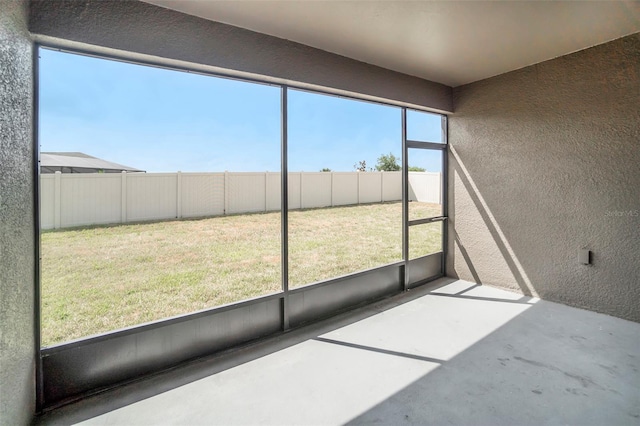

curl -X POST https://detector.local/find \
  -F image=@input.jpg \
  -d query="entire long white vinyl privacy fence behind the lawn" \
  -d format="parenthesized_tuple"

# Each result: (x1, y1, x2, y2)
(40, 172, 442, 229)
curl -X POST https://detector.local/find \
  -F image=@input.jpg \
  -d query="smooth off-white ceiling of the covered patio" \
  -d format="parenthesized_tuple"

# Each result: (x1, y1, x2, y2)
(145, 0, 640, 87)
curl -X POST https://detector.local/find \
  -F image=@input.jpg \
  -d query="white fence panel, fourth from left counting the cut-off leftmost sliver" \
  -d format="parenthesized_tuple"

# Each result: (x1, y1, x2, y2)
(180, 173, 225, 217)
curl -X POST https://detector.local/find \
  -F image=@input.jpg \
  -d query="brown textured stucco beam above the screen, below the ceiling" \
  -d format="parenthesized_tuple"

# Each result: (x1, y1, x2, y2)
(30, 0, 451, 111)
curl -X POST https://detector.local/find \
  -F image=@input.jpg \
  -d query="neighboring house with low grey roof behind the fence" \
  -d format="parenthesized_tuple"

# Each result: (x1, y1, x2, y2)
(40, 152, 145, 173)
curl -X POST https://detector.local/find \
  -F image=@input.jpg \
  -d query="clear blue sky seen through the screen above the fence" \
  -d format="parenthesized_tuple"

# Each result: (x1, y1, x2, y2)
(39, 49, 440, 172)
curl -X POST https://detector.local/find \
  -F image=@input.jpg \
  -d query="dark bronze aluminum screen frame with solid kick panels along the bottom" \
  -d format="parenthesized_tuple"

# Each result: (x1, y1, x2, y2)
(33, 43, 448, 412)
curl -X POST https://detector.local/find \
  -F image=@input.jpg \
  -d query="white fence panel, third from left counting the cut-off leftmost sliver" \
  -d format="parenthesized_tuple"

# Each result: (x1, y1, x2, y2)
(123, 173, 178, 222)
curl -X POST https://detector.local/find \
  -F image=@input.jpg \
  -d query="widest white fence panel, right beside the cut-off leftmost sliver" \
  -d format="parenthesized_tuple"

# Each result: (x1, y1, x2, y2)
(60, 173, 122, 228)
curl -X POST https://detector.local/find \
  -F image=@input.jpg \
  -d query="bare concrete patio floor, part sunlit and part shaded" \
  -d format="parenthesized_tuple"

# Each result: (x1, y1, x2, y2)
(38, 279, 640, 425)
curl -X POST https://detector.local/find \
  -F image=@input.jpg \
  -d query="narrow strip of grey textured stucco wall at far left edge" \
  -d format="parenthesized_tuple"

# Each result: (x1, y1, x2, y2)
(0, 0, 35, 425)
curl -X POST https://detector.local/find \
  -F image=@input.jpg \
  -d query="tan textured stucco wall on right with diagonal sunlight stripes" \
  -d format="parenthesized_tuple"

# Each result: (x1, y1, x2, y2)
(447, 34, 640, 321)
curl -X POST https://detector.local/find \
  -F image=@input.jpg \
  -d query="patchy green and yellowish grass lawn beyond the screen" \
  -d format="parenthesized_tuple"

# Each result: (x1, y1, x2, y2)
(41, 203, 441, 346)
